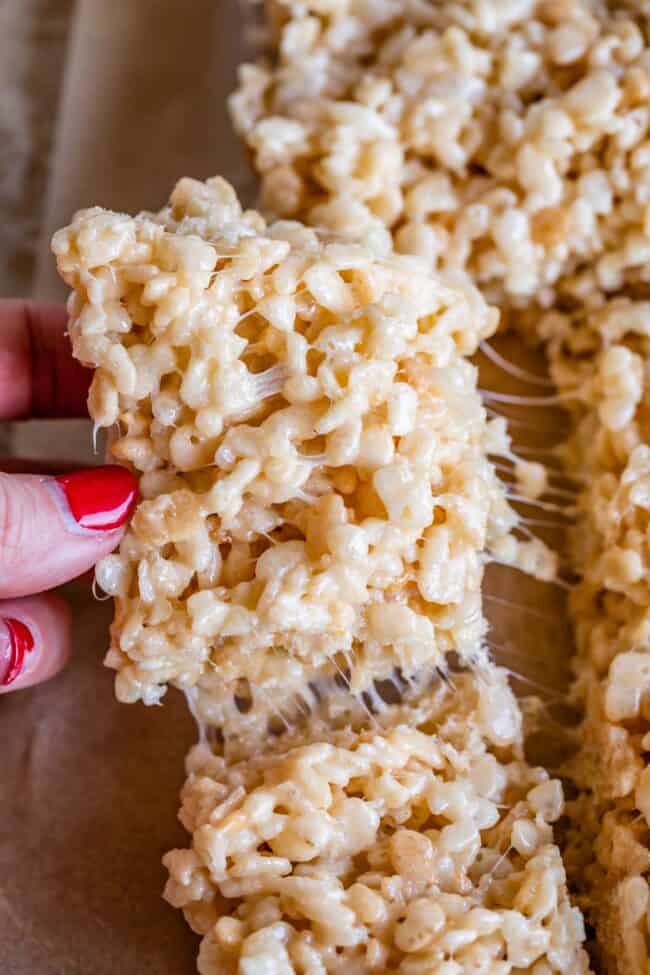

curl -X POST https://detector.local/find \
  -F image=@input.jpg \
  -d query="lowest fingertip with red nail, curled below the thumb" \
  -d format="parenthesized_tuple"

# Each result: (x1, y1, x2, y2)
(0, 593, 70, 694)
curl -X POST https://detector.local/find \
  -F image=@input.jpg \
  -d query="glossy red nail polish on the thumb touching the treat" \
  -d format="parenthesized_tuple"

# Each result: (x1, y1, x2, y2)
(56, 465, 138, 532)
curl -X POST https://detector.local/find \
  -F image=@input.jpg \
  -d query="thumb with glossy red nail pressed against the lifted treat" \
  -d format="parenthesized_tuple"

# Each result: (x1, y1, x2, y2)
(0, 466, 137, 599)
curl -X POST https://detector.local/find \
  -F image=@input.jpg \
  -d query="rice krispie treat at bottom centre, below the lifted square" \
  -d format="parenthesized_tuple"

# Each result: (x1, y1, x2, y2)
(165, 670, 588, 975)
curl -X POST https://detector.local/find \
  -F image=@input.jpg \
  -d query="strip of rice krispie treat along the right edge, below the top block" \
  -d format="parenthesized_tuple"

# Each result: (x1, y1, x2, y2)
(540, 299, 650, 975)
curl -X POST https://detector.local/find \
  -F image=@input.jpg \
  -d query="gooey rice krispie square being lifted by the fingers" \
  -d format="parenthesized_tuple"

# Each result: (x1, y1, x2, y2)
(53, 179, 554, 740)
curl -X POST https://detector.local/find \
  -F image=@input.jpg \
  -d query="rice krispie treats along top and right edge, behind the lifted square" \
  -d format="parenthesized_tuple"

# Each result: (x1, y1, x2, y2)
(231, 0, 650, 975)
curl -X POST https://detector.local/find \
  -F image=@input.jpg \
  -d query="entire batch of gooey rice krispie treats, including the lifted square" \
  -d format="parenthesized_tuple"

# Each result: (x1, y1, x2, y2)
(45, 0, 650, 975)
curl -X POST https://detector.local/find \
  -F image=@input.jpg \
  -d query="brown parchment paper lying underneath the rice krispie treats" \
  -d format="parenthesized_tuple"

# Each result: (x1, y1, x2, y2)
(0, 0, 570, 975)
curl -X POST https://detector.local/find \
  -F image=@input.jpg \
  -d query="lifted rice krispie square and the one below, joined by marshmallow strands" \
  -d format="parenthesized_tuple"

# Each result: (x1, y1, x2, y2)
(53, 179, 588, 975)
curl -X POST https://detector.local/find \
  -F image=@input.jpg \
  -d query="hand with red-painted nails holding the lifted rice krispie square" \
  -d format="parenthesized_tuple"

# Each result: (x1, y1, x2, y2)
(0, 300, 137, 693)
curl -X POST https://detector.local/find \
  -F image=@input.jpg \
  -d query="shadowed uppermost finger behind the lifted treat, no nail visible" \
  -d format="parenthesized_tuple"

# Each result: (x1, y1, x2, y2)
(0, 299, 91, 420)
